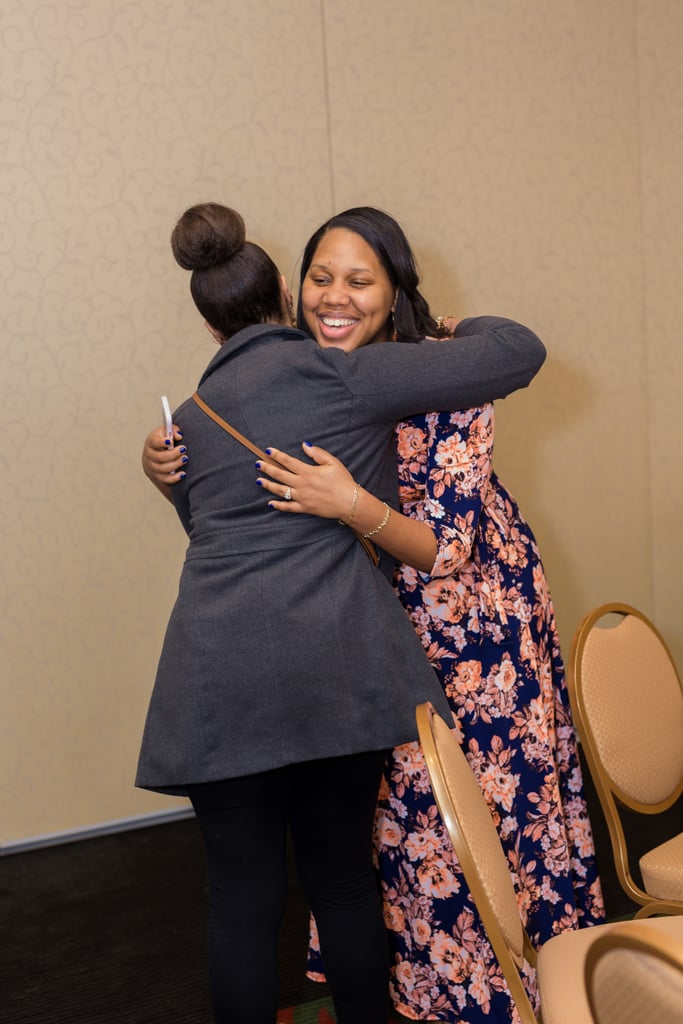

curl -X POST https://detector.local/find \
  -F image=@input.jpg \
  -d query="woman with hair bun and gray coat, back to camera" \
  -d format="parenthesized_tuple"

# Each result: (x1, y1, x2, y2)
(136, 204, 545, 1024)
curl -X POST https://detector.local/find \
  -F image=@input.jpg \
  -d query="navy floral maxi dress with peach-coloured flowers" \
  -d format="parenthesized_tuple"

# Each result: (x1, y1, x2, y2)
(375, 406, 604, 1024)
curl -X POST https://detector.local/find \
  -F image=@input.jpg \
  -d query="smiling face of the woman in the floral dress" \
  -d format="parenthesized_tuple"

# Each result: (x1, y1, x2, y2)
(301, 227, 394, 352)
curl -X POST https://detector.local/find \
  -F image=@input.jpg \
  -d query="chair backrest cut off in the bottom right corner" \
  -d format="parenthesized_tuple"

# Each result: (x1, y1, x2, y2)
(585, 919, 683, 1024)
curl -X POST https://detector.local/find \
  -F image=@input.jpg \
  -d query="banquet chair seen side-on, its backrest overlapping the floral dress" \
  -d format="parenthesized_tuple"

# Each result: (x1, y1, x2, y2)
(416, 702, 683, 1024)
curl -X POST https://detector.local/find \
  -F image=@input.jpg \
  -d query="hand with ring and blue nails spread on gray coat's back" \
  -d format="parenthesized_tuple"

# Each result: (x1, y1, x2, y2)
(256, 443, 355, 521)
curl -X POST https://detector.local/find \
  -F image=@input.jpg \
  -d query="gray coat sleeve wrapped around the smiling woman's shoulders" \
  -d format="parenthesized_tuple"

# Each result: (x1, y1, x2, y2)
(333, 316, 546, 423)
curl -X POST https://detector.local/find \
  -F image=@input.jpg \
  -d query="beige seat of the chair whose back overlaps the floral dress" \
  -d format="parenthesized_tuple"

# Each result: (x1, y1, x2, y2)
(538, 916, 683, 1024)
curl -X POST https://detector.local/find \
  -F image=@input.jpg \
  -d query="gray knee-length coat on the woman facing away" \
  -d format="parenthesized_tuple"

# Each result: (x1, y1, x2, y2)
(136, 317, 545, 794)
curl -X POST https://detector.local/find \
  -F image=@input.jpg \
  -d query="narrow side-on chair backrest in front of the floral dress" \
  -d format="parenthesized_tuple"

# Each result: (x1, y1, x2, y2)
(417, 703, 537, 1024)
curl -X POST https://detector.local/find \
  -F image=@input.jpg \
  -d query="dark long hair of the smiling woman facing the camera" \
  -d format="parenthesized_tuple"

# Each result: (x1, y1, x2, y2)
(297, 206, 444, 341)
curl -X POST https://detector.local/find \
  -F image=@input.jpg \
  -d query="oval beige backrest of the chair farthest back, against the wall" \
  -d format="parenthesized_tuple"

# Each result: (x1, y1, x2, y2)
(568, 603, 683, 813)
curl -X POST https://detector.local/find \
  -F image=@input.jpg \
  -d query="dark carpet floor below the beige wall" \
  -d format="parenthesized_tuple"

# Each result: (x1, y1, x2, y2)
(0, 757, 683, 1024)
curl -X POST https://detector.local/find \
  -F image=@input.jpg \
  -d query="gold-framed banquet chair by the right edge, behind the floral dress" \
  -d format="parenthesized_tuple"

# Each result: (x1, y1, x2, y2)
(567, 602, 683, 918)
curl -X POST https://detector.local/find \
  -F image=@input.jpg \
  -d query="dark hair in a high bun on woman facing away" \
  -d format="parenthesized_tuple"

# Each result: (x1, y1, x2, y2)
(171, 203, 282, 338)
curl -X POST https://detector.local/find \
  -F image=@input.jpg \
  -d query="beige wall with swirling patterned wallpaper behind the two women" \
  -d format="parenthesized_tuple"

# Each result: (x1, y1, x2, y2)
(0, 0, 683, 848)
